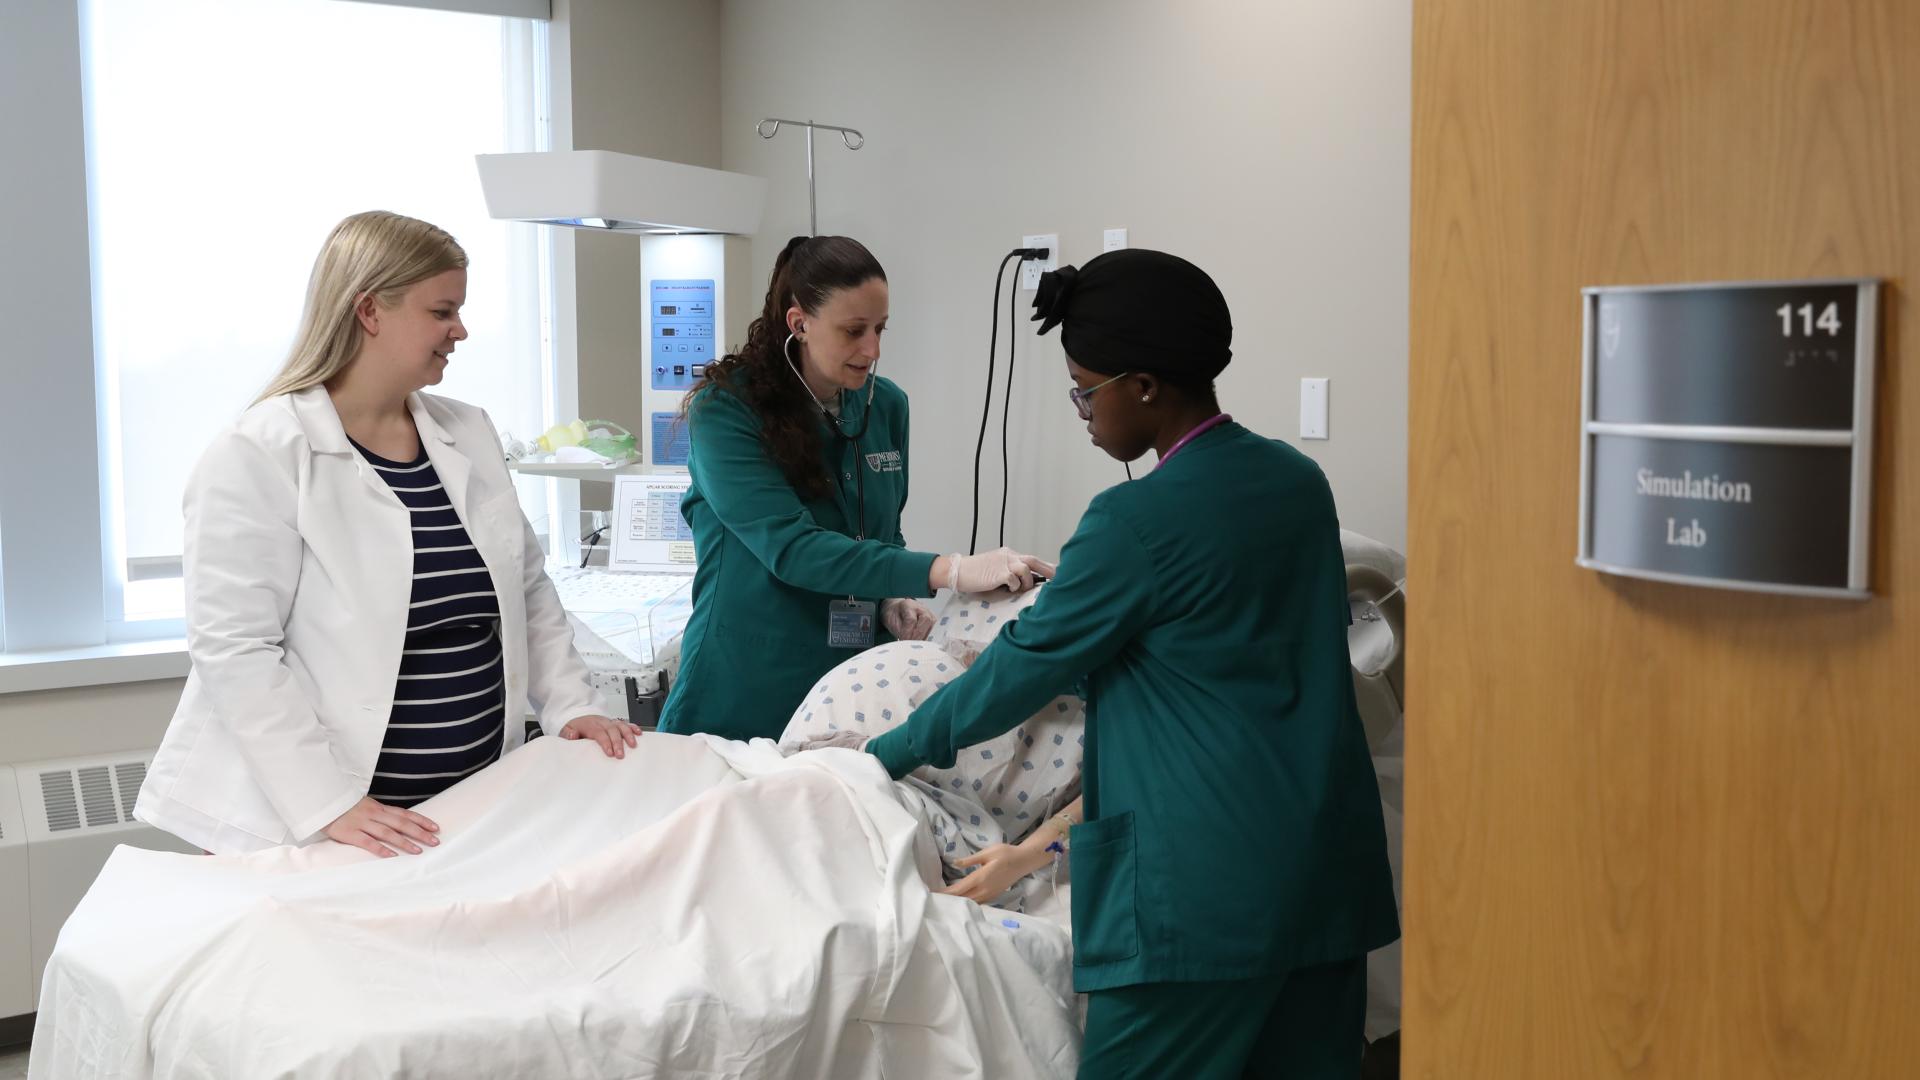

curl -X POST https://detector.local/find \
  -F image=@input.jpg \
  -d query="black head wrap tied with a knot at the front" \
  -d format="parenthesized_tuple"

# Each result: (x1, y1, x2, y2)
(1033, 248, 1233, 382)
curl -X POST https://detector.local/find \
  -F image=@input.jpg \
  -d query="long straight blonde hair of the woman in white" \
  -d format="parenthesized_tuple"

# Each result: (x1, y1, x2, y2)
(253, 209, 467, 404)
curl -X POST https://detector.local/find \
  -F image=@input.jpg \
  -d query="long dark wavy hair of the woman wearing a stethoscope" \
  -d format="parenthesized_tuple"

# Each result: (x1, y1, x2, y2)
(680, 236, 887, 500)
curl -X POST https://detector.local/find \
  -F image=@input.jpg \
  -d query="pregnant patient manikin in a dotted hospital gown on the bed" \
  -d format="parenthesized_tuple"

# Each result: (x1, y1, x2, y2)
(780, 590, 1087, 911)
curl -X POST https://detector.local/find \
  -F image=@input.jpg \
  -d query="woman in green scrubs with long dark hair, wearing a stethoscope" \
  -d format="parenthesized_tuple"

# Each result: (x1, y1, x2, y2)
(660, 236, 1048, 738)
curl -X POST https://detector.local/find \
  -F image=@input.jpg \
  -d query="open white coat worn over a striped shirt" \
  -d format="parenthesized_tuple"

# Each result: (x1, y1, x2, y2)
(134, 386, 605, 853)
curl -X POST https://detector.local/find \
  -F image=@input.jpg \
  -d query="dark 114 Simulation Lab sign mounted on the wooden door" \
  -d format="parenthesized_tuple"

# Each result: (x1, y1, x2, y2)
(1580, 281, 1880, 598)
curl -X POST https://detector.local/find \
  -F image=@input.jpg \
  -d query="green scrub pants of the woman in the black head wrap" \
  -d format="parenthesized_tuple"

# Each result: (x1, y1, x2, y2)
(1079, 957, 1367, 1080)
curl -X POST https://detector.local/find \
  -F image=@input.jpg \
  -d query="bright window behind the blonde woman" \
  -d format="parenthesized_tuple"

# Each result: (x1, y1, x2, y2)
(81, 0, 553, 622)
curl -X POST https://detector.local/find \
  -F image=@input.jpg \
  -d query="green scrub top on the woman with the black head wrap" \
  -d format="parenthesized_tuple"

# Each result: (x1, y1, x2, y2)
(868, 423, 1400, 992)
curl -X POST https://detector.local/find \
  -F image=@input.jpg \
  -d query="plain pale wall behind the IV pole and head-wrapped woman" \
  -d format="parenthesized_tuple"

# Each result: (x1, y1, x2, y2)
(720, 0, 1413, 553)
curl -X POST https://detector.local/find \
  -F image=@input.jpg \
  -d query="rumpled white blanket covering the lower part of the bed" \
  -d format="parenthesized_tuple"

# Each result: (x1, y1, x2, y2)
(29, 734, 1079, 1080)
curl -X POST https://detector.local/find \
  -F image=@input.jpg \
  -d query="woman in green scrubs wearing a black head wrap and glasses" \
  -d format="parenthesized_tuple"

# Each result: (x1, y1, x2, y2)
(866, 250, 1400, 1080)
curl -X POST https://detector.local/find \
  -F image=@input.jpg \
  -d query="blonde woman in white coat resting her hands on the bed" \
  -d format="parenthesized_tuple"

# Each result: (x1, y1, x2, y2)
(134, 211, 639, 857)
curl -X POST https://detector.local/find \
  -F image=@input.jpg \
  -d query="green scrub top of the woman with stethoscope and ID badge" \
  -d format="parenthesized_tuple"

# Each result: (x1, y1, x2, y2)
(660, 377, 935, 740)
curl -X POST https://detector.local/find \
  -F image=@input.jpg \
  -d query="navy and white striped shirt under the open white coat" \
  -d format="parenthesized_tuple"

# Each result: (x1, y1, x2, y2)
(353, 432, 507, 807)
